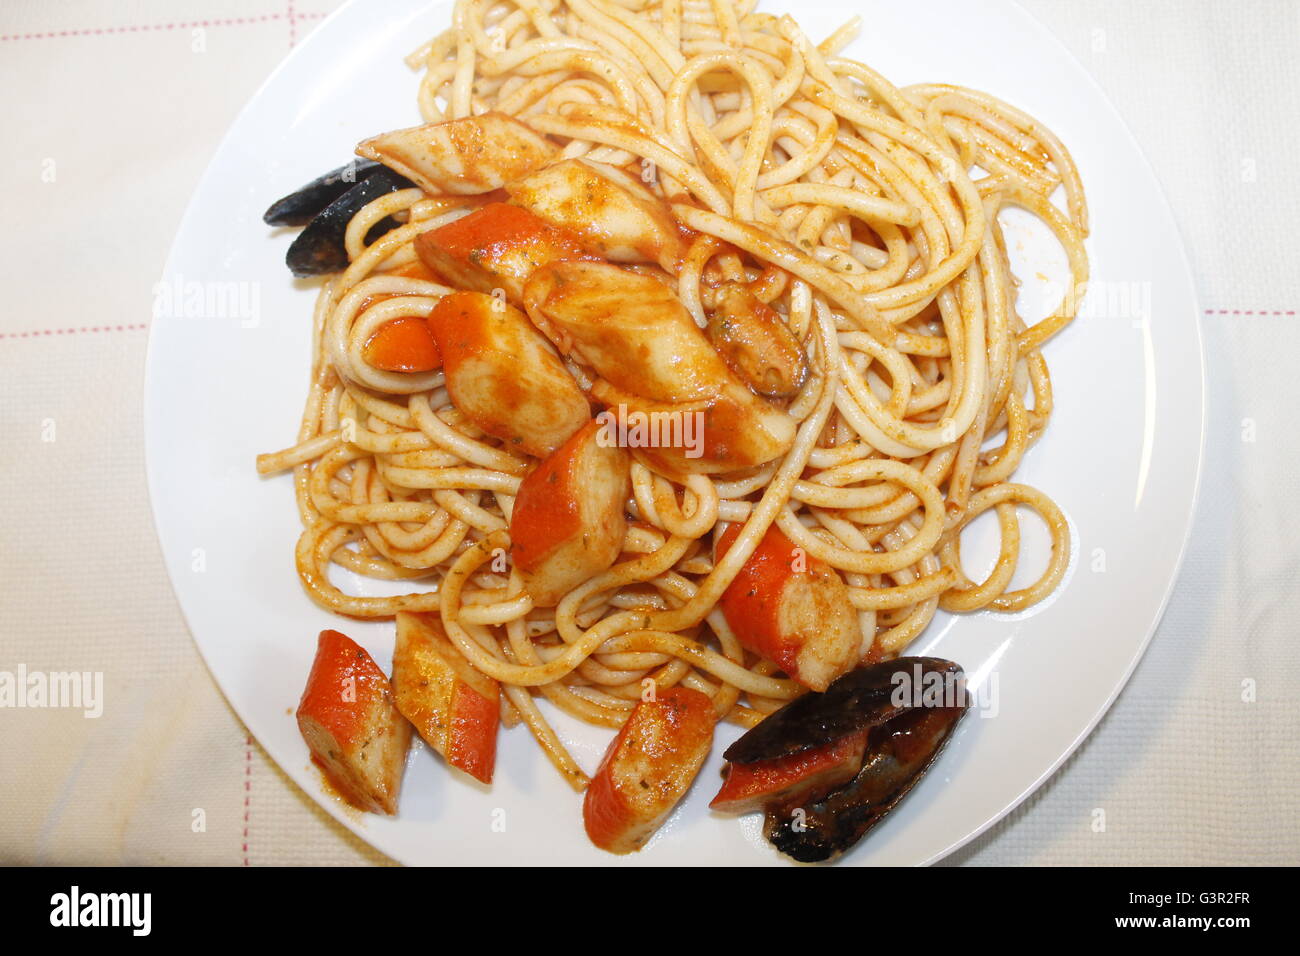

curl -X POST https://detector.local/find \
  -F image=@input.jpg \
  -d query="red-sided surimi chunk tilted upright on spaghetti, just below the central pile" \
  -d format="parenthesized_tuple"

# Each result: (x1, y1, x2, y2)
(510, 421, 632, 607)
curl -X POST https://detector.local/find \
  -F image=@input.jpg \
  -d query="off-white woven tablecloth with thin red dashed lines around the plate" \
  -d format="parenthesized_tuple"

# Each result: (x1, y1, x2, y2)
(0, 0, 1300, 865)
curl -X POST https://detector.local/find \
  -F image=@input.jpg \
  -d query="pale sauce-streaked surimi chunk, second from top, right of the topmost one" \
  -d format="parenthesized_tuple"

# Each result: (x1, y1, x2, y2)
(506, 159, 681, 272)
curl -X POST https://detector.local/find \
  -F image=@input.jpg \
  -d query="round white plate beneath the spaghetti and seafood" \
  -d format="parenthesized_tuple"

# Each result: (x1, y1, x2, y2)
(146, 0, 1204, 865)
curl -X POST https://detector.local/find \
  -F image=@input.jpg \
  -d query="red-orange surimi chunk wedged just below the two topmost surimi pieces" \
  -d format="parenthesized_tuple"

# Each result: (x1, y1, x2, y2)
(415, 203, 592, 306)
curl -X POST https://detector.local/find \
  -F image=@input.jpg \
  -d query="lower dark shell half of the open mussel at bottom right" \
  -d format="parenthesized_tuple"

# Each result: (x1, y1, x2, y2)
(763, 706, 966, 862)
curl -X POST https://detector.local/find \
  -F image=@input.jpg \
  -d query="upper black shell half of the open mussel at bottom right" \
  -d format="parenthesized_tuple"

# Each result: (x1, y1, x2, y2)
(723, 657, 962, 763)
